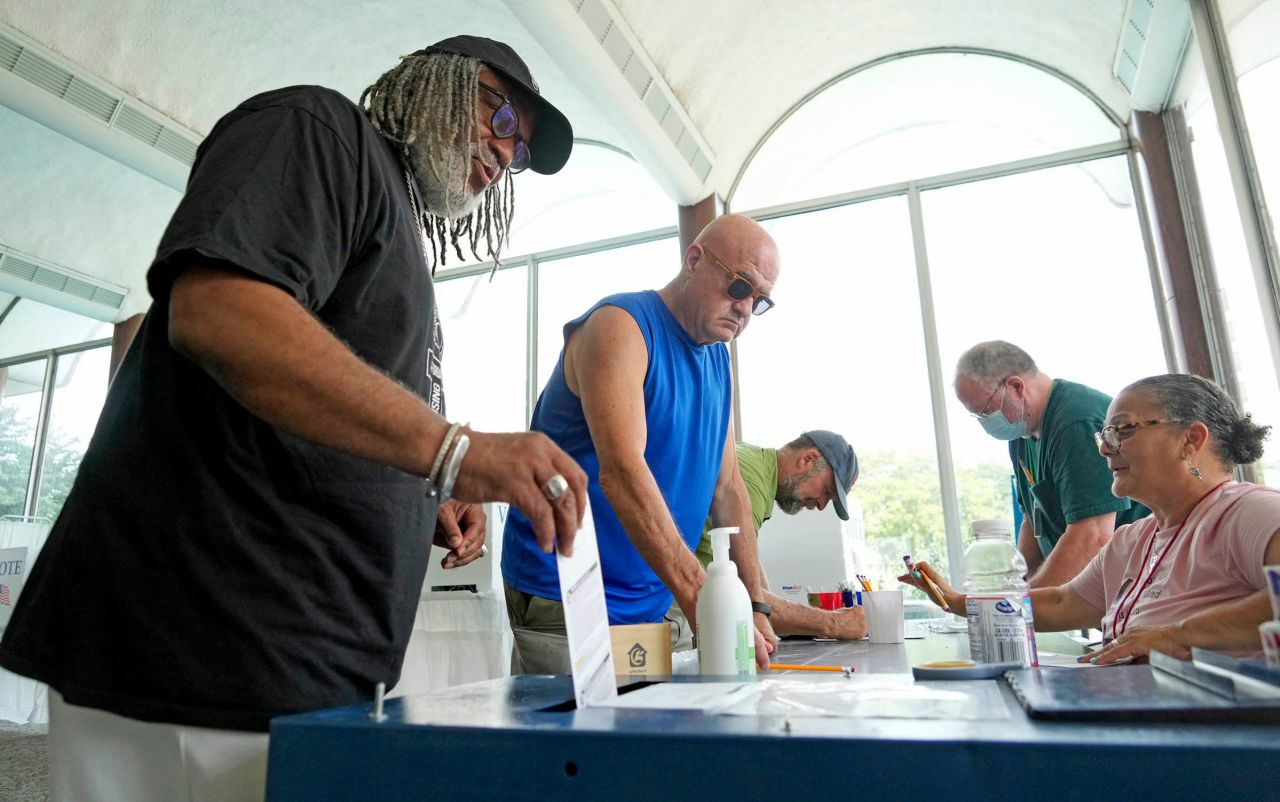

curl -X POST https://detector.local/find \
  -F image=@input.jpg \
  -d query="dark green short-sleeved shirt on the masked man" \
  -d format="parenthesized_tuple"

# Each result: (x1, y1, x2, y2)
(1009, 379, 1151, 556)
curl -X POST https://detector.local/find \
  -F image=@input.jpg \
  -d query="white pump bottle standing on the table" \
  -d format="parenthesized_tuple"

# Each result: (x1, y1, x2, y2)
(698, 526, 755, 677)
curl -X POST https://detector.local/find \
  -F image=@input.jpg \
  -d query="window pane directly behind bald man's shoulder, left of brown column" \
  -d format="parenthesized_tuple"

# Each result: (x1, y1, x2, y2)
(536, 237, 681, 391)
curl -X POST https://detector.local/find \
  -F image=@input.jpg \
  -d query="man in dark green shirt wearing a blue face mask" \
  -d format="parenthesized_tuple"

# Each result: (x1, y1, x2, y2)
(955, 340, 1151, 588)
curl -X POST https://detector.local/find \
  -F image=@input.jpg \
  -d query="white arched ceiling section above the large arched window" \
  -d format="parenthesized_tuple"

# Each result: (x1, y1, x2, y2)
(616, 0, 1129, 193)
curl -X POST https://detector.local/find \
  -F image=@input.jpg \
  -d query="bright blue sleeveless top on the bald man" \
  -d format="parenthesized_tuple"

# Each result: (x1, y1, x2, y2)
(502, 290, 732, 624)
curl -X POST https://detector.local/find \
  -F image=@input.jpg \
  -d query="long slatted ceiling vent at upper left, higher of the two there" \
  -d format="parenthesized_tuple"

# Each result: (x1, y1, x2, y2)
(0, 26, 200, 189)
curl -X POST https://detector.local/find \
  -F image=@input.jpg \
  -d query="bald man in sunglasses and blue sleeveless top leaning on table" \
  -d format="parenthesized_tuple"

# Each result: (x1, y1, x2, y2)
(502, 215, 778, 674)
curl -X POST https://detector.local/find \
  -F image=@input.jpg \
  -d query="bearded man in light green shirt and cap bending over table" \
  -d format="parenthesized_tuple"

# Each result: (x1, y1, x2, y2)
(668, 430, 867, 640)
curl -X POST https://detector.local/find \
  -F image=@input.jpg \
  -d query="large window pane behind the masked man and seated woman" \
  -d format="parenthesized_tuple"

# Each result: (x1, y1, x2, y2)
(922, 157, 1167, 524)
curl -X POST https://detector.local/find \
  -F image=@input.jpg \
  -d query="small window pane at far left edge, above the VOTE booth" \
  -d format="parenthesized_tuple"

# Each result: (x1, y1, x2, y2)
(0, 359, 47, 515)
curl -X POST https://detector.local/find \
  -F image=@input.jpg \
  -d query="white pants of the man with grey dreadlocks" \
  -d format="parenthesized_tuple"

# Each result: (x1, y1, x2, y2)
(49, 688, 268, 802)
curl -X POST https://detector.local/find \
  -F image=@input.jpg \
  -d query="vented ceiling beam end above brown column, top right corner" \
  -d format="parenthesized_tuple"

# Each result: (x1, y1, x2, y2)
(1112, 0, 1192, 111)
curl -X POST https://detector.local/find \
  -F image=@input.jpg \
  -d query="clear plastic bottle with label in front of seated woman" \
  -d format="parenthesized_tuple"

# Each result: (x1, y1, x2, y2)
(964, 521, 1039, 668)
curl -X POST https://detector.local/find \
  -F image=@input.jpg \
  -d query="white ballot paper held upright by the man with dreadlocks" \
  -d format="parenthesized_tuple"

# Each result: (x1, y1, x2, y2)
(556, 503, 618, 707)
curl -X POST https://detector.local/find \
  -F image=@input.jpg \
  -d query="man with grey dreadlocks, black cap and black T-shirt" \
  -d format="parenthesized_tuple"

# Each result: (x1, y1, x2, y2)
(0, 37, 586, 801)
